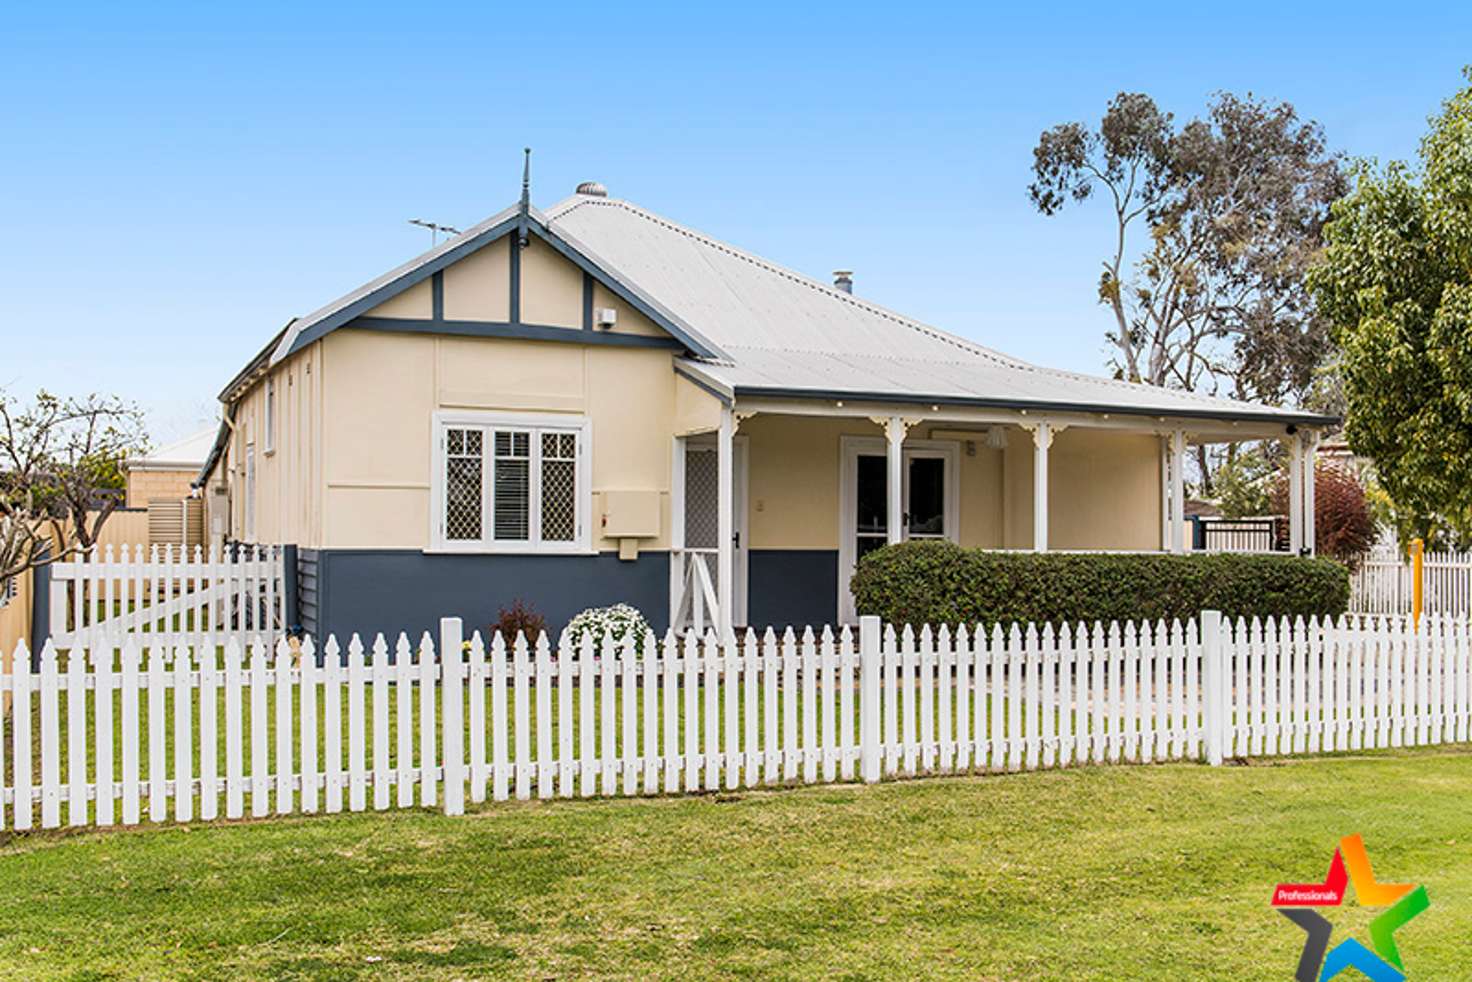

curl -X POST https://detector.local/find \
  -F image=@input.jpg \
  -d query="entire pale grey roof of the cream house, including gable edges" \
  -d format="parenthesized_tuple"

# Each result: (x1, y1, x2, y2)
(206, 194, 1335, 432)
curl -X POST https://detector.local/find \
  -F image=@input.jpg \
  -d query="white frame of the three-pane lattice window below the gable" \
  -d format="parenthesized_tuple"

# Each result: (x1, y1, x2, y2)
(427, 409, 593, 555)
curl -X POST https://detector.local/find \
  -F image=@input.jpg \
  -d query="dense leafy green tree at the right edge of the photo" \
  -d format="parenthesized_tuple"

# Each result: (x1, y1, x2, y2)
(1309, 69, 1472, 539)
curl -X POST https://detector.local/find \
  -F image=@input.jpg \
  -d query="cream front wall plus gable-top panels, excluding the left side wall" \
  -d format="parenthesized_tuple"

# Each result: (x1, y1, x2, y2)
(307, 236, 720, 549)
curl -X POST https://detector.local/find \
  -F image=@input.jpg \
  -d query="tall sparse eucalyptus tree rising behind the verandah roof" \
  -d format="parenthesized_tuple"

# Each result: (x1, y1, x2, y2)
(1029, 93, 1345, 402)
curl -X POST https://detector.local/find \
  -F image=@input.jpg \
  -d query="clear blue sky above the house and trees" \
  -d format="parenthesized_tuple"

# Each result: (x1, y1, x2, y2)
(0, 1, 1472, 440)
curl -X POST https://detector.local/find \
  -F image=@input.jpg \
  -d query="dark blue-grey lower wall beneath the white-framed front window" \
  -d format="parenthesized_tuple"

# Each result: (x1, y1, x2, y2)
(319, 549, 670, 643)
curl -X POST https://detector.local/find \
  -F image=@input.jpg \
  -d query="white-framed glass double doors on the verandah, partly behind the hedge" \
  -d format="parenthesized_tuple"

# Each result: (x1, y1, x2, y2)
(838, 437, 958, 623)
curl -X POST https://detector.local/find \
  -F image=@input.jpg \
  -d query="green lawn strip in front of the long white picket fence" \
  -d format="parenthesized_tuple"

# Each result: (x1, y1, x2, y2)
(0, 749, 1472, 979)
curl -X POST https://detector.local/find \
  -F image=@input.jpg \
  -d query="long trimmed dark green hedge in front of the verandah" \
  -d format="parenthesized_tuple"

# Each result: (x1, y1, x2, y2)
(852, 542, 1350, 626)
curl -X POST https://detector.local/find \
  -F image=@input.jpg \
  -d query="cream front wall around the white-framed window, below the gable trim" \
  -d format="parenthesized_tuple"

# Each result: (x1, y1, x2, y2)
(322, 328, 677, 549)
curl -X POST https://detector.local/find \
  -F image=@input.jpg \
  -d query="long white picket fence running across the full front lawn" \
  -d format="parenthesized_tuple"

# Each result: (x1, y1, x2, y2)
(0, 611, 1472, 829)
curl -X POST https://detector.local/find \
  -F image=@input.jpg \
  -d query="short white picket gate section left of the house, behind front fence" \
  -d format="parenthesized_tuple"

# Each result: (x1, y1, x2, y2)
(47, 545, 287, 649)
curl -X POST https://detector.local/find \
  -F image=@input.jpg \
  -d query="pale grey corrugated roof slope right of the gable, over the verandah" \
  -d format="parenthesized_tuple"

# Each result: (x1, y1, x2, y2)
(546, 196, 1328, 421)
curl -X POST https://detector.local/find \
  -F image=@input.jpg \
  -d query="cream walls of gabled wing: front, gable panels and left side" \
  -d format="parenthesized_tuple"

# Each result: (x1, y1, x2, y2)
(216, 236, 700, 549)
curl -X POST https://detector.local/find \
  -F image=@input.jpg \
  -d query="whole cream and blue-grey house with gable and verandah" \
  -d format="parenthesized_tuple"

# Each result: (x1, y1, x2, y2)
(197, 172, 1334, 635)
